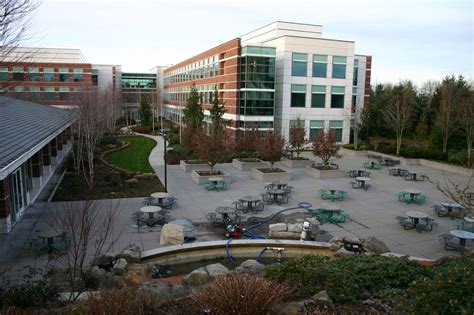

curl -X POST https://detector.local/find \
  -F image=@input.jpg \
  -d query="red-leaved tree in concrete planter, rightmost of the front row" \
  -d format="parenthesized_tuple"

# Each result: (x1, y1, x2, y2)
(306, 130, 344, 179)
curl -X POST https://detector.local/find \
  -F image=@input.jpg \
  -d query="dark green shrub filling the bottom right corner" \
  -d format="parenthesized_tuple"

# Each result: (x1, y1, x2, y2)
(400, 258, 474, 314)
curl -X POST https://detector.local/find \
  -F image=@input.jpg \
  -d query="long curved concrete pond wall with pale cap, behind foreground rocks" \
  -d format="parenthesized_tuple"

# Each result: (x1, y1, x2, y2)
(140, 240, 335, 265)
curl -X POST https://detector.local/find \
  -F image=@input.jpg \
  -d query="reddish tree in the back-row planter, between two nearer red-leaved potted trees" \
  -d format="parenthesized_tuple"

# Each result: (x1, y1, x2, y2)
(282, 118, 311, 168)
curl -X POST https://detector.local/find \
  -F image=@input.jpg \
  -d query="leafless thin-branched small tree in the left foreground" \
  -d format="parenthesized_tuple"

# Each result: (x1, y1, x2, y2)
(46, 198, 120, 300)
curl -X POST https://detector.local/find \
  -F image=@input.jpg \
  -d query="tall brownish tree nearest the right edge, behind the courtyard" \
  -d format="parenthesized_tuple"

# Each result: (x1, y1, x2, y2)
(435, 75, 469, 152)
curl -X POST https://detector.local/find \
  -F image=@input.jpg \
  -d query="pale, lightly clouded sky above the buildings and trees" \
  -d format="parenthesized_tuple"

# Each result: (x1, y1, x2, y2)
(25, 0, 474, 85)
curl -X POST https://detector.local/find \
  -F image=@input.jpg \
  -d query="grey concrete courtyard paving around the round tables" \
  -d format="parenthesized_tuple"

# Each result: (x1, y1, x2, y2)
(0, 137, 469, 267)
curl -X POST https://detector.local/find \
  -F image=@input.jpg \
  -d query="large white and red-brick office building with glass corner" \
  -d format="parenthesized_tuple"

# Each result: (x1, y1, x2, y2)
(163, 22, 372, 143)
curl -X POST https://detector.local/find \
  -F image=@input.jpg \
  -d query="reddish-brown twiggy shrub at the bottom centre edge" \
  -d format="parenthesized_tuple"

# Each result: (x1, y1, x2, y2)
(191, 273, 291, 314)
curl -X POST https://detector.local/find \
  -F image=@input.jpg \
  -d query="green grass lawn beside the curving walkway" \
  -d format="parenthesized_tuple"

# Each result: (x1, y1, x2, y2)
(105, 136, 156, 173)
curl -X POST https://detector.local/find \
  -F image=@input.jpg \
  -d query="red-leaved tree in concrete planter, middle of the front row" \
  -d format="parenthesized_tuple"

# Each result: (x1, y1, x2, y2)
(251, 131, 291, 182)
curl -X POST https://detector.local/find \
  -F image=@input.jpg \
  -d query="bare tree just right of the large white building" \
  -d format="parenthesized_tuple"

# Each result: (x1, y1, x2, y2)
(382, 81, 415, 154)
